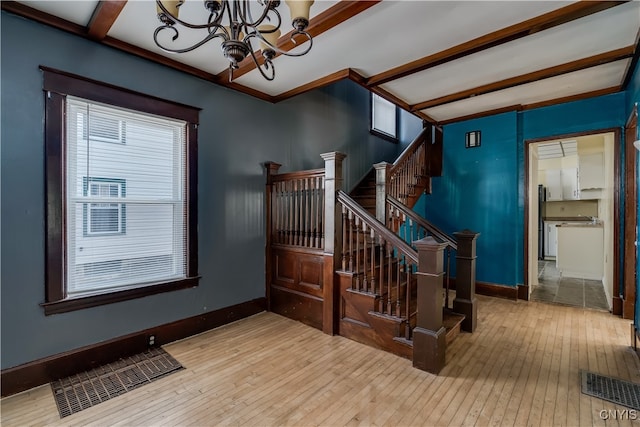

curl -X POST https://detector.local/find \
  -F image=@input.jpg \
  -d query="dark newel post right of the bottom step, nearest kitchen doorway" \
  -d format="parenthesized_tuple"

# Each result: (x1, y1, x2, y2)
(453, 230, 480, 332)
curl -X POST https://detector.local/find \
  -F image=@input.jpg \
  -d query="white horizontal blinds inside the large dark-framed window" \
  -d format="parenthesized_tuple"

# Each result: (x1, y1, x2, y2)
(65, 96, 187, 297)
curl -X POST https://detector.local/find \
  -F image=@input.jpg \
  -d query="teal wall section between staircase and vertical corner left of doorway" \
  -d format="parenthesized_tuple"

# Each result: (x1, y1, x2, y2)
(425, 112, 518, 285)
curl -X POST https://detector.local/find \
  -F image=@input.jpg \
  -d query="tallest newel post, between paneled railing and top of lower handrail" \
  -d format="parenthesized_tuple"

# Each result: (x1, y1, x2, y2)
(320, 151, 347, 335)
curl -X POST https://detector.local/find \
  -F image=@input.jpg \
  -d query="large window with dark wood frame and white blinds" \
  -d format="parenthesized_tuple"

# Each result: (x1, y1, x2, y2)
(42, 67, 198, 314)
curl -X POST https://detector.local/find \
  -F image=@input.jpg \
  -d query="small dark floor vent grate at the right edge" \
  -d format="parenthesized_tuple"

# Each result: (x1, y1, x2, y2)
(580, 371, 640, 410)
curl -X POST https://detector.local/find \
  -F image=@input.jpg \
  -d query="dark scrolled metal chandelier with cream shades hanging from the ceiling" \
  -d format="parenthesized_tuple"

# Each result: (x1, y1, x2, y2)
(153, 0, 313, 81)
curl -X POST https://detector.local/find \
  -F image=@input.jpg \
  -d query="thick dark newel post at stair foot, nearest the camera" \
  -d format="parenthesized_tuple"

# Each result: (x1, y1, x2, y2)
(413, 236, 447, 374)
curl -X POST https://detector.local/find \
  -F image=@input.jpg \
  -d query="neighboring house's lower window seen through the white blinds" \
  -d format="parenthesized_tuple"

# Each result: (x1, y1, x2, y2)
(83, 177, 127, 236)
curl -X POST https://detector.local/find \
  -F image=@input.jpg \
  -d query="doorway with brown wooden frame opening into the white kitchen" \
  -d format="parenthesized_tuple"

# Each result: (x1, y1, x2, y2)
(525, 129, 619, 311)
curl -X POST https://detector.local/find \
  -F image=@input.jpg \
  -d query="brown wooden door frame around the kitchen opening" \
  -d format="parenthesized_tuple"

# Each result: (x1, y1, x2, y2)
(518, 128, 628, 315)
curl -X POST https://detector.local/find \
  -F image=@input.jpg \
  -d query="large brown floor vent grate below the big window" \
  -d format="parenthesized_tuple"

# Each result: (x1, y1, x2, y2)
(51, 348, 183, 418)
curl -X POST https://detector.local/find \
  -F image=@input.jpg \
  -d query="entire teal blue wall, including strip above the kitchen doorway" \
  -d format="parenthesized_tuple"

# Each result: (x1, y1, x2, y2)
(416, 93, 626, 286)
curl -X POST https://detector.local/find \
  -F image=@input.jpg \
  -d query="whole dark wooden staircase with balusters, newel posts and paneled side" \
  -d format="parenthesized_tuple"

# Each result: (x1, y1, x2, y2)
(265, 123, 477, 373)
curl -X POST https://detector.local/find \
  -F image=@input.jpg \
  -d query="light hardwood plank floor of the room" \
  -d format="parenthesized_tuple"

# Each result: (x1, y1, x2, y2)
(0, 296, 640, 426)
